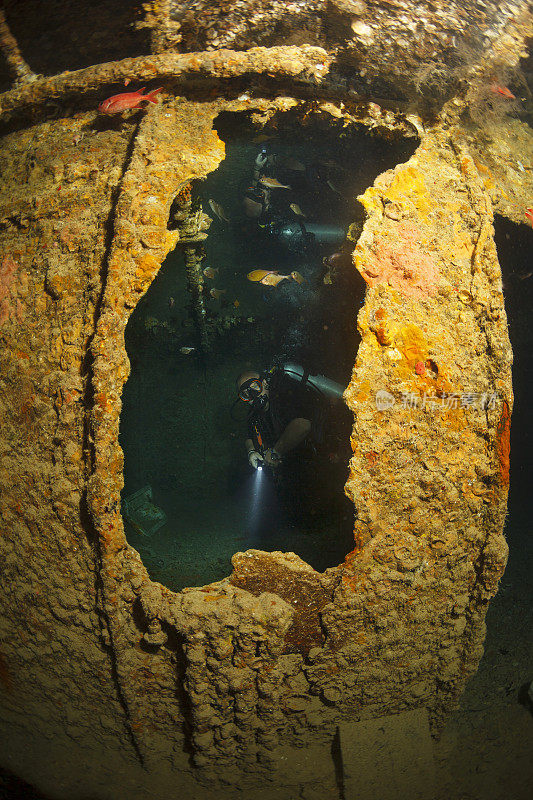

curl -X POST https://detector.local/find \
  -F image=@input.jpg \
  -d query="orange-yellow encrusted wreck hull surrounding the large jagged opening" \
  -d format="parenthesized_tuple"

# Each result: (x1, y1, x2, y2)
(0, 2, 531, 800)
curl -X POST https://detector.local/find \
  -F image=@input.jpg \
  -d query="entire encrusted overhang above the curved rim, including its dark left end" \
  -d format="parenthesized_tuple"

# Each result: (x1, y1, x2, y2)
(0, 0, 531, 107)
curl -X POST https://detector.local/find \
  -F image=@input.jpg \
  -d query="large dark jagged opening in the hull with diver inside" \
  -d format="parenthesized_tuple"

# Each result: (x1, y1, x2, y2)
(120, 113, 417, 591)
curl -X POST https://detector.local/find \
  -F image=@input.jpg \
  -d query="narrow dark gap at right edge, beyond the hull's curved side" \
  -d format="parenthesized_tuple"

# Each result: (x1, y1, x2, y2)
(470, 215, 533, 752)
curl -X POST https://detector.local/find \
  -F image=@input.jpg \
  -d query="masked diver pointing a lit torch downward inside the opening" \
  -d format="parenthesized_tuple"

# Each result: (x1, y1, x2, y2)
(236, 363, 344, 470)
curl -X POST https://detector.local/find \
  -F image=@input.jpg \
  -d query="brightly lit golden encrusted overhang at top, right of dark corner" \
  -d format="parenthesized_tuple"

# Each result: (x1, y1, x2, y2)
(156, 0, 531, 103)
